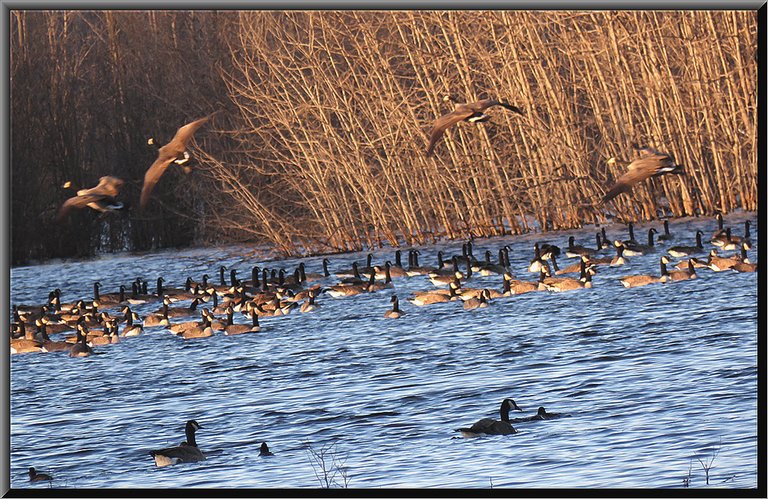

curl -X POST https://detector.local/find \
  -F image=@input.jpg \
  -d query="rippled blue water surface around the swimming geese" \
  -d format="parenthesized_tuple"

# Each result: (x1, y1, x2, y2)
(10, 214, 758, 488)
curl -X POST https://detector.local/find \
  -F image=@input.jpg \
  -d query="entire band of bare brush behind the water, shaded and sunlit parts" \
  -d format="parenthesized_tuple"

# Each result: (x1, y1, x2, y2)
(9, 10, 757, 264)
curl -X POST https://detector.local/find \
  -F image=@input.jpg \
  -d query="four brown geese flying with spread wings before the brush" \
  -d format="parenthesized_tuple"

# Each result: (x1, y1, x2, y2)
(56, 96, 685, 222)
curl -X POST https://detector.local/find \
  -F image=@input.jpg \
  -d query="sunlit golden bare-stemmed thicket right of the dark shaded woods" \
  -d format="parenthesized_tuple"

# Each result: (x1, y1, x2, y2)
(200, 11, 757, 253)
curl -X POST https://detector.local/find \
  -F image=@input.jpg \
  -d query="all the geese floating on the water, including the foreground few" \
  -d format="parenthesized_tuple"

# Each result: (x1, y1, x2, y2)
(10, 210, 757, 480)
